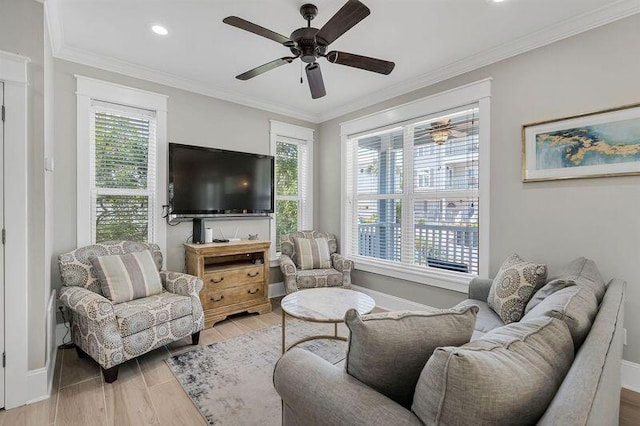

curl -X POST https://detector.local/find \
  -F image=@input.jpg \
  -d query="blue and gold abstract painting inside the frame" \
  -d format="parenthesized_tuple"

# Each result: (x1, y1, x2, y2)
(535, 118, 640, 170)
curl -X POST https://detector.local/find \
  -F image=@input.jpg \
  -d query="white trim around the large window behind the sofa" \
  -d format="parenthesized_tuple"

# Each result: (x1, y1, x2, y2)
(340, 78, 491, 293)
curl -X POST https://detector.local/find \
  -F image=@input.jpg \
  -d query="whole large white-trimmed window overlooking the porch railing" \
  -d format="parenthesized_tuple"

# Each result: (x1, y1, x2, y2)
(342, 81, 490, 290)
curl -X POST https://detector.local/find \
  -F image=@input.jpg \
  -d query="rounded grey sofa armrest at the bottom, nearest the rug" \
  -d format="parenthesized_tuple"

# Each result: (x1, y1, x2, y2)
(273, 348, 422, 426)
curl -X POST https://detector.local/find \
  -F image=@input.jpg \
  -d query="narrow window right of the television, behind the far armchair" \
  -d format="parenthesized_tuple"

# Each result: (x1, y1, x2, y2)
(271, 121, 313, 257)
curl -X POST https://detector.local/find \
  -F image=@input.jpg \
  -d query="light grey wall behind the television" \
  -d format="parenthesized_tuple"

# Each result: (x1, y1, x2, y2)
(53, 59, 317, 287)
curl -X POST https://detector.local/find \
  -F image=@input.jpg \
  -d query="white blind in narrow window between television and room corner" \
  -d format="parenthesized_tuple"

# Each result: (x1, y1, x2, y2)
(275, 136, 311, 252)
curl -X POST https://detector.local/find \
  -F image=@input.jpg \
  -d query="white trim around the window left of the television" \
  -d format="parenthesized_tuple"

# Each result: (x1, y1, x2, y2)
(75, 75, 168, 265)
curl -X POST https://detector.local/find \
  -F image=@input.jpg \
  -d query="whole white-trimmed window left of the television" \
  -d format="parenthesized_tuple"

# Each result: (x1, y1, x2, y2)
(77, 76, 166, 251)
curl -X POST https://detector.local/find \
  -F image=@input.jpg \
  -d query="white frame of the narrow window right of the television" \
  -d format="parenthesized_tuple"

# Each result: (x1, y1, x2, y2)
(269, 120, 314, 267)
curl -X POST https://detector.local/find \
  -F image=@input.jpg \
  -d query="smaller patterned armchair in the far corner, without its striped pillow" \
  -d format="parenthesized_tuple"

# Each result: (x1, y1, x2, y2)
(280, 231, 353, 294)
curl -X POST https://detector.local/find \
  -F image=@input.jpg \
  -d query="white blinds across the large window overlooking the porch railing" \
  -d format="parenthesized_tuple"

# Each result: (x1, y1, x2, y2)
(345, 105, 480, 274)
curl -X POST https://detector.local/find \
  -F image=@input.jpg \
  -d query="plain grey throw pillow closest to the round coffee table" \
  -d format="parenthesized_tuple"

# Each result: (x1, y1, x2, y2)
(345, 306, 478, 408)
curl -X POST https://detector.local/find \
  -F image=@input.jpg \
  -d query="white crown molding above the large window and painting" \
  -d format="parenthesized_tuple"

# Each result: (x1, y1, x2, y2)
(320, 0, 640, 122)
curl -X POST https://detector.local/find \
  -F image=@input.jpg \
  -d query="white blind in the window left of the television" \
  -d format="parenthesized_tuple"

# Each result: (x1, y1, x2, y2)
(89, 100, 157, 242)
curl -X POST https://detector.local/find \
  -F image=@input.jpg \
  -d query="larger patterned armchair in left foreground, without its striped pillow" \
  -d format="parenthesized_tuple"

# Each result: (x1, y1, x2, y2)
(58, 241, 204, 383)
